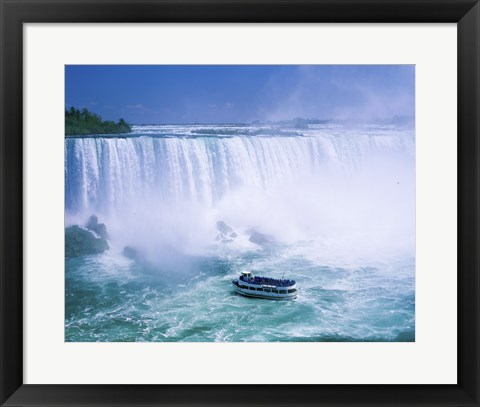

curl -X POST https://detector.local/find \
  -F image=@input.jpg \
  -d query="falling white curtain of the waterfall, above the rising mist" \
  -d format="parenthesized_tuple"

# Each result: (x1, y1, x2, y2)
(65, 130, 413, 212)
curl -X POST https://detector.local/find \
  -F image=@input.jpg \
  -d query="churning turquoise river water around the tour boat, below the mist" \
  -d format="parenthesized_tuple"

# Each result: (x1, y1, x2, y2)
(66, 247, 415, 342)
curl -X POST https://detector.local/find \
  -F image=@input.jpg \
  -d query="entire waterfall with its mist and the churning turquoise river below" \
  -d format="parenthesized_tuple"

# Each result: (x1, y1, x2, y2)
(65, 123, 415, 342)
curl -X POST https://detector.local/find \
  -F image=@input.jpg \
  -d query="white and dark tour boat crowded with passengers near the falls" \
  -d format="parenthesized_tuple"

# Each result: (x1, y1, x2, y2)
(232, 271, 298, 300)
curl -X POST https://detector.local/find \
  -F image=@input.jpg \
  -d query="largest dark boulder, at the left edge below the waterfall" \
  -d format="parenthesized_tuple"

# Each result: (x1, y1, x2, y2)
(65, 225, 109, 257)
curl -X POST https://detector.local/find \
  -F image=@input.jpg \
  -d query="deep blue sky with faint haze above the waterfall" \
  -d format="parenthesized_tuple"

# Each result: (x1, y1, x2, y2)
(65, 65, 415, 124)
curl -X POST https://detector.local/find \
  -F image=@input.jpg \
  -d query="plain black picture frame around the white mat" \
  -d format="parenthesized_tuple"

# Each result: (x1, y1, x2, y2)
(0, 0, 480, 406)
